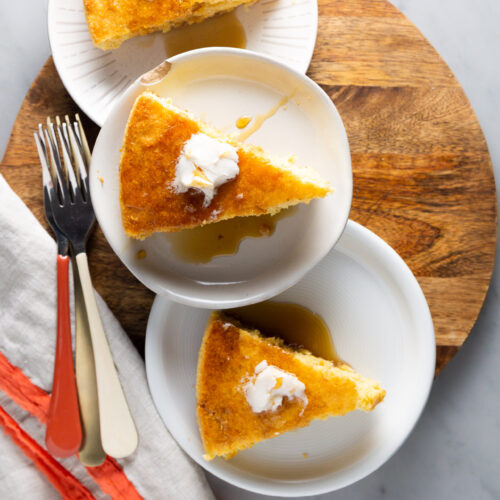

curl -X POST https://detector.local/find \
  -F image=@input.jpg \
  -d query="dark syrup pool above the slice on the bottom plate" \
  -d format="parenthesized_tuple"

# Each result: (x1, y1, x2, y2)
(224, 300, 342, 363)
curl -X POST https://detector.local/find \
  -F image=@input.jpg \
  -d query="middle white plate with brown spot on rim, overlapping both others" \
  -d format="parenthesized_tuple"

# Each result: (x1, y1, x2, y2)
(90, 48, 352, 308)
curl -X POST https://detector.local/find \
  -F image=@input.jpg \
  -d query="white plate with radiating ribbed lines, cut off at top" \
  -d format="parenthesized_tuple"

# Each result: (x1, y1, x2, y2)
(48, 0, 318, 126)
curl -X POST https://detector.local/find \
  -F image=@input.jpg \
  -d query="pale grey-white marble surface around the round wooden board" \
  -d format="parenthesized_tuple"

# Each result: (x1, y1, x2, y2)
(0, 0, 500, 500)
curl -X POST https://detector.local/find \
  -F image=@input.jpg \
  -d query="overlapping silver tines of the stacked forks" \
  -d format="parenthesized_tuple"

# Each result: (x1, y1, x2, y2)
(34, 115, 90, 204)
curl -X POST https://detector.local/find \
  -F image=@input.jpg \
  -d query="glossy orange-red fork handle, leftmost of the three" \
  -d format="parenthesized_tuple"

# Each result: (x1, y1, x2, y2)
(45, 255, 82, 458)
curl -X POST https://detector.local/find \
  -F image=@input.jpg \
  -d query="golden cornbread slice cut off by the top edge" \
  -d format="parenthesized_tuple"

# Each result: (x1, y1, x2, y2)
(83, 0, 256, 50)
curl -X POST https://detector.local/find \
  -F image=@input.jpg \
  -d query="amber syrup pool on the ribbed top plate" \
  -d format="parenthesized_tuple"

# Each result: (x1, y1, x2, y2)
(165, 11, 247, 57)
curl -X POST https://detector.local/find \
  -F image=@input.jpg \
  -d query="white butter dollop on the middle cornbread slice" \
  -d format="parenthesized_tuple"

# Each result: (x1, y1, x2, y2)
(172, 132, 240, 207)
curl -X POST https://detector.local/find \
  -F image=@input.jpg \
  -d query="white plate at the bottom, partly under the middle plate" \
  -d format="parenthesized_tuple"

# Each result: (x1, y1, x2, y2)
(146, 221, 435, 497)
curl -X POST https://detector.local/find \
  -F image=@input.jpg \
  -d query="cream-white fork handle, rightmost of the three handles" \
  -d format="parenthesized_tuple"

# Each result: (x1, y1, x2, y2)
(76, 252, 138, 458)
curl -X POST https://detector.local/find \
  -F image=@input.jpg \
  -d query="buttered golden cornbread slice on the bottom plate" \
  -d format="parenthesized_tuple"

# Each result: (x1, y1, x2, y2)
(196, 312, 385, 460)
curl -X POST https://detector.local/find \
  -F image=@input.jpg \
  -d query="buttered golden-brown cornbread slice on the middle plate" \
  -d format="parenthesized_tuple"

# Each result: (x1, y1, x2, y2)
(120, 91, 332, 239)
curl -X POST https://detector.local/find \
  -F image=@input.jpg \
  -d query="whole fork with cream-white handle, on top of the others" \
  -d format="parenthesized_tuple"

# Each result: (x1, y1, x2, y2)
(35, 119, 138, 458)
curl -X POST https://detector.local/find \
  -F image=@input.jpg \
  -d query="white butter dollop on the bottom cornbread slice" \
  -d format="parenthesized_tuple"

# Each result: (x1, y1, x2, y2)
(243, 360, 308, 415)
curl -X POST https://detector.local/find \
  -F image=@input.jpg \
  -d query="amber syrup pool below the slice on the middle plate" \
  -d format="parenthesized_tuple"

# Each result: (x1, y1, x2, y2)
(165, 207, 297, 264)
